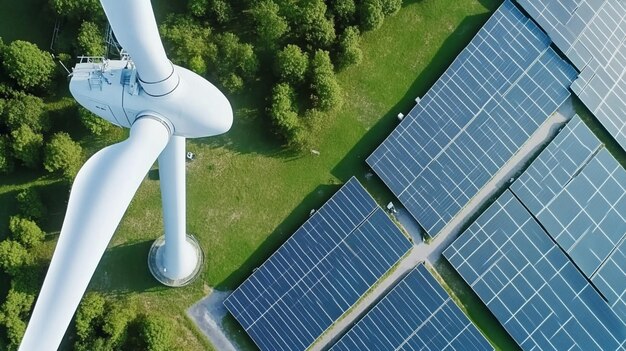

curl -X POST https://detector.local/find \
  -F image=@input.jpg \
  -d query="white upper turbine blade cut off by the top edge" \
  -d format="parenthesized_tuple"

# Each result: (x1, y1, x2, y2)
(100, 0, 178, 95)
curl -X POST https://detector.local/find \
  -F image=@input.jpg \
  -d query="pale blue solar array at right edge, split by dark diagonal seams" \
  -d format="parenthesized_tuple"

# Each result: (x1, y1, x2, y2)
(511, 117, 626, 322)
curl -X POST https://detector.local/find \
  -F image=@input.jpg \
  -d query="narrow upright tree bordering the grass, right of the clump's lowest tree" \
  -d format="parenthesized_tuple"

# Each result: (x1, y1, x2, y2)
(311, 50, 342, 111)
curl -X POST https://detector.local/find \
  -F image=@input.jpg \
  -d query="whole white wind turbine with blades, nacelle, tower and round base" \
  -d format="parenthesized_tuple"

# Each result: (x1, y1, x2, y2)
(19, 0, 233, 351)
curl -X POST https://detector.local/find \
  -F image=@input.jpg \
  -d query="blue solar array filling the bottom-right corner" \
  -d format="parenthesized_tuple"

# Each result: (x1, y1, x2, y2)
(444, 190, 626, 351)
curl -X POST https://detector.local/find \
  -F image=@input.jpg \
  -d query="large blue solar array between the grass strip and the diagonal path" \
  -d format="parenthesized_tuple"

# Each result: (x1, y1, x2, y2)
(367, 1, 576, 237)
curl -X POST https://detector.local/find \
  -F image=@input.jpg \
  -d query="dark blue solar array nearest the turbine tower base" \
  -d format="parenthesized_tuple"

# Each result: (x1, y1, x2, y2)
(224, 178, 411, 350)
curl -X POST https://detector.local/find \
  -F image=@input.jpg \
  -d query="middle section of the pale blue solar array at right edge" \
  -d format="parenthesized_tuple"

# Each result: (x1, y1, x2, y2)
(537, 149, 626, 277)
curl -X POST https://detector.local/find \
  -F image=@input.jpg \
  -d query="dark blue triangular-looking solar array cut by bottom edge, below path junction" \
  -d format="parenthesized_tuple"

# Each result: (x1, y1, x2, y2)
(330, 265, 493, 351)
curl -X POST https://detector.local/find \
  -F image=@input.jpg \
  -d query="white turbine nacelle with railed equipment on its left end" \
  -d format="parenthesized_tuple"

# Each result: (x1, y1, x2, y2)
(70, 58, 233, 138)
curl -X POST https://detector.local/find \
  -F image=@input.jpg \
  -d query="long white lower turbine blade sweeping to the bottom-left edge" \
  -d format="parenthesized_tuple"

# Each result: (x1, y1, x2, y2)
(19, 117, 171, 351)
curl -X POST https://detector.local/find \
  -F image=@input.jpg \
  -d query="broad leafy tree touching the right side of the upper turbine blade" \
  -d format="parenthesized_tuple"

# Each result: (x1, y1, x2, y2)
(160, 15, 217, 74)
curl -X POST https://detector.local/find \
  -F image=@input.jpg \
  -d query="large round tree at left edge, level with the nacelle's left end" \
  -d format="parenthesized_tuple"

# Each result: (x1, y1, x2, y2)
(2, 40, 55, 89)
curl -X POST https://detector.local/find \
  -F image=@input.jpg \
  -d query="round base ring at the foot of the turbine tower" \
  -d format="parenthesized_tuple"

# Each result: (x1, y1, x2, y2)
(148, 234, 204, 287)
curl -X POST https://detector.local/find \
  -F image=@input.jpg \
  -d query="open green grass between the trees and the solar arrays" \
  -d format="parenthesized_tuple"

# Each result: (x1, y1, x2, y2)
(0, 0, 512, 350)
